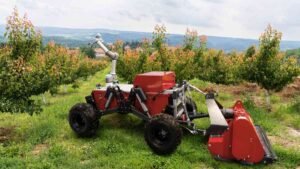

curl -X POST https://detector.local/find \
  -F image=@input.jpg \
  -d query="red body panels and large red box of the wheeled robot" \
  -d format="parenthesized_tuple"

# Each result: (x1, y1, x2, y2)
(92, 72, 176, 116)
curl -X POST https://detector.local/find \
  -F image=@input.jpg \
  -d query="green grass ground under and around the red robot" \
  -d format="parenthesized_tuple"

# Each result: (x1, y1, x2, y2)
(0, 69, 300, 169)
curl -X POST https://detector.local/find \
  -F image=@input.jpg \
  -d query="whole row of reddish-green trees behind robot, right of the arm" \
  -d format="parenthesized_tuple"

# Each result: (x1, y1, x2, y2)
(117, 26, 299, 88)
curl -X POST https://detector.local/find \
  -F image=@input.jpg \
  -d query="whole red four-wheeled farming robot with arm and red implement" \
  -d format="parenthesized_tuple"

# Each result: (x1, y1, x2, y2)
(69, 36, 277, 164)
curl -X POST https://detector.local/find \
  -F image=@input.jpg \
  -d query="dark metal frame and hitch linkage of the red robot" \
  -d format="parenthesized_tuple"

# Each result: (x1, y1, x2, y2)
(86, 82, 217, 135)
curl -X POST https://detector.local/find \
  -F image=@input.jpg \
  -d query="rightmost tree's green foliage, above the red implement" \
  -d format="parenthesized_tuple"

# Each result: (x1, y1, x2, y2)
(243, 25, 299, 91)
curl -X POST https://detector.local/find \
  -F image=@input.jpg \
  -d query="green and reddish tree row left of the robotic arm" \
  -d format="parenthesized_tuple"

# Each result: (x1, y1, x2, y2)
(0, 9, 105, 114)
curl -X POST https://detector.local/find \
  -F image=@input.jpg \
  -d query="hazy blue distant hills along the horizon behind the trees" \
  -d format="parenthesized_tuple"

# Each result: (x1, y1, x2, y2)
(0, 25, 300, 52)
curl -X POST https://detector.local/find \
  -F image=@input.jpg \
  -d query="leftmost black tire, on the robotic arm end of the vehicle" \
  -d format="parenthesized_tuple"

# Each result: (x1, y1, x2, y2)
(69, 103, 99, 137)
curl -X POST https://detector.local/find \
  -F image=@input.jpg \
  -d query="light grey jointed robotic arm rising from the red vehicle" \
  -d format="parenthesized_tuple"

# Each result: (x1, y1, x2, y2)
(95, 34, 119, 83)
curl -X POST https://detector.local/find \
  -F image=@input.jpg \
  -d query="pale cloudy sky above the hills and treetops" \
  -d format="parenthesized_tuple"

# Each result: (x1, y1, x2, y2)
(0, 0, 300, 40)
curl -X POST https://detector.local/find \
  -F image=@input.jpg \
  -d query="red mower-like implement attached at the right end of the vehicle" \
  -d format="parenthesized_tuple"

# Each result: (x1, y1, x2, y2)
(208, 101, 277, 164)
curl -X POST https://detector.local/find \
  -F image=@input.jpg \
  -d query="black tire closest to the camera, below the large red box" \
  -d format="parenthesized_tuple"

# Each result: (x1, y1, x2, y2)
(144, 114, 182, 155)
